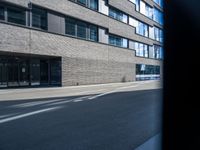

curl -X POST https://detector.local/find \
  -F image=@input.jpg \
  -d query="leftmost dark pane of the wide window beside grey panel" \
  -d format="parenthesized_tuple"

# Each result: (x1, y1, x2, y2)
(65, 18, 76, 36)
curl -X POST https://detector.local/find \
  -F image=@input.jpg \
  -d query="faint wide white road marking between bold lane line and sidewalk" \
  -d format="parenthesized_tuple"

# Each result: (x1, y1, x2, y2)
(11, 98, 66, 107)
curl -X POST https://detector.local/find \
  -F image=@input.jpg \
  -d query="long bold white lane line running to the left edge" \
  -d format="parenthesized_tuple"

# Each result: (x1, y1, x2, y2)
(0, 107, 61, 124)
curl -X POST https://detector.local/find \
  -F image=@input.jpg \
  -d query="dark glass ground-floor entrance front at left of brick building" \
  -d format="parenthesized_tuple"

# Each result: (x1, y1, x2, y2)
(0, 54, 61, 88)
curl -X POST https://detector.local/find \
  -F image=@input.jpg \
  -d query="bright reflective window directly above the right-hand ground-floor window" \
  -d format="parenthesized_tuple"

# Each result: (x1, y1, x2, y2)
(133, 42, 149, 57)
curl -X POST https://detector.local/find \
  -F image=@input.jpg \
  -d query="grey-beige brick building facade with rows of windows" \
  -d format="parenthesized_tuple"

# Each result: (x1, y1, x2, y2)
(0, 0, 163, 88)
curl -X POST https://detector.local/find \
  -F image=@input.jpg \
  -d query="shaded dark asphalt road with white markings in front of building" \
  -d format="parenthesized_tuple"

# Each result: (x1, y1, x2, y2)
(0, 89, 162, 150)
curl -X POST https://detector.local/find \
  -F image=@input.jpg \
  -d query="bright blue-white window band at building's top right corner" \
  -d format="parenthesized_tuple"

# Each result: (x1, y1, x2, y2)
(130, 0, 163, 25)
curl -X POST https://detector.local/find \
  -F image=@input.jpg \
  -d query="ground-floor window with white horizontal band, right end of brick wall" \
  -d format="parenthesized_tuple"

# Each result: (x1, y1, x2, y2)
(136, 64, 160, 81)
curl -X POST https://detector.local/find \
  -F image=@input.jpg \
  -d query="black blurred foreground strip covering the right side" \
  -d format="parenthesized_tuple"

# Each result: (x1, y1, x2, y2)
(163, 0, 200, 150)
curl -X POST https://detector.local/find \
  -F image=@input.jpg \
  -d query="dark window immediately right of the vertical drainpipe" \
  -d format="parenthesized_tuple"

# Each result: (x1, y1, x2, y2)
(32, 6, 47, 30)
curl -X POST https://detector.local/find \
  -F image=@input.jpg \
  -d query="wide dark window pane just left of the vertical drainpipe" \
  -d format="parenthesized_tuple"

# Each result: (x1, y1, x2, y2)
(7, 7, 26, 25)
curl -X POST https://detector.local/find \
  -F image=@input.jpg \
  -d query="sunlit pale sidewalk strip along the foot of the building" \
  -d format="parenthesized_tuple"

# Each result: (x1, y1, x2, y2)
(0, 81, 161, 101)
